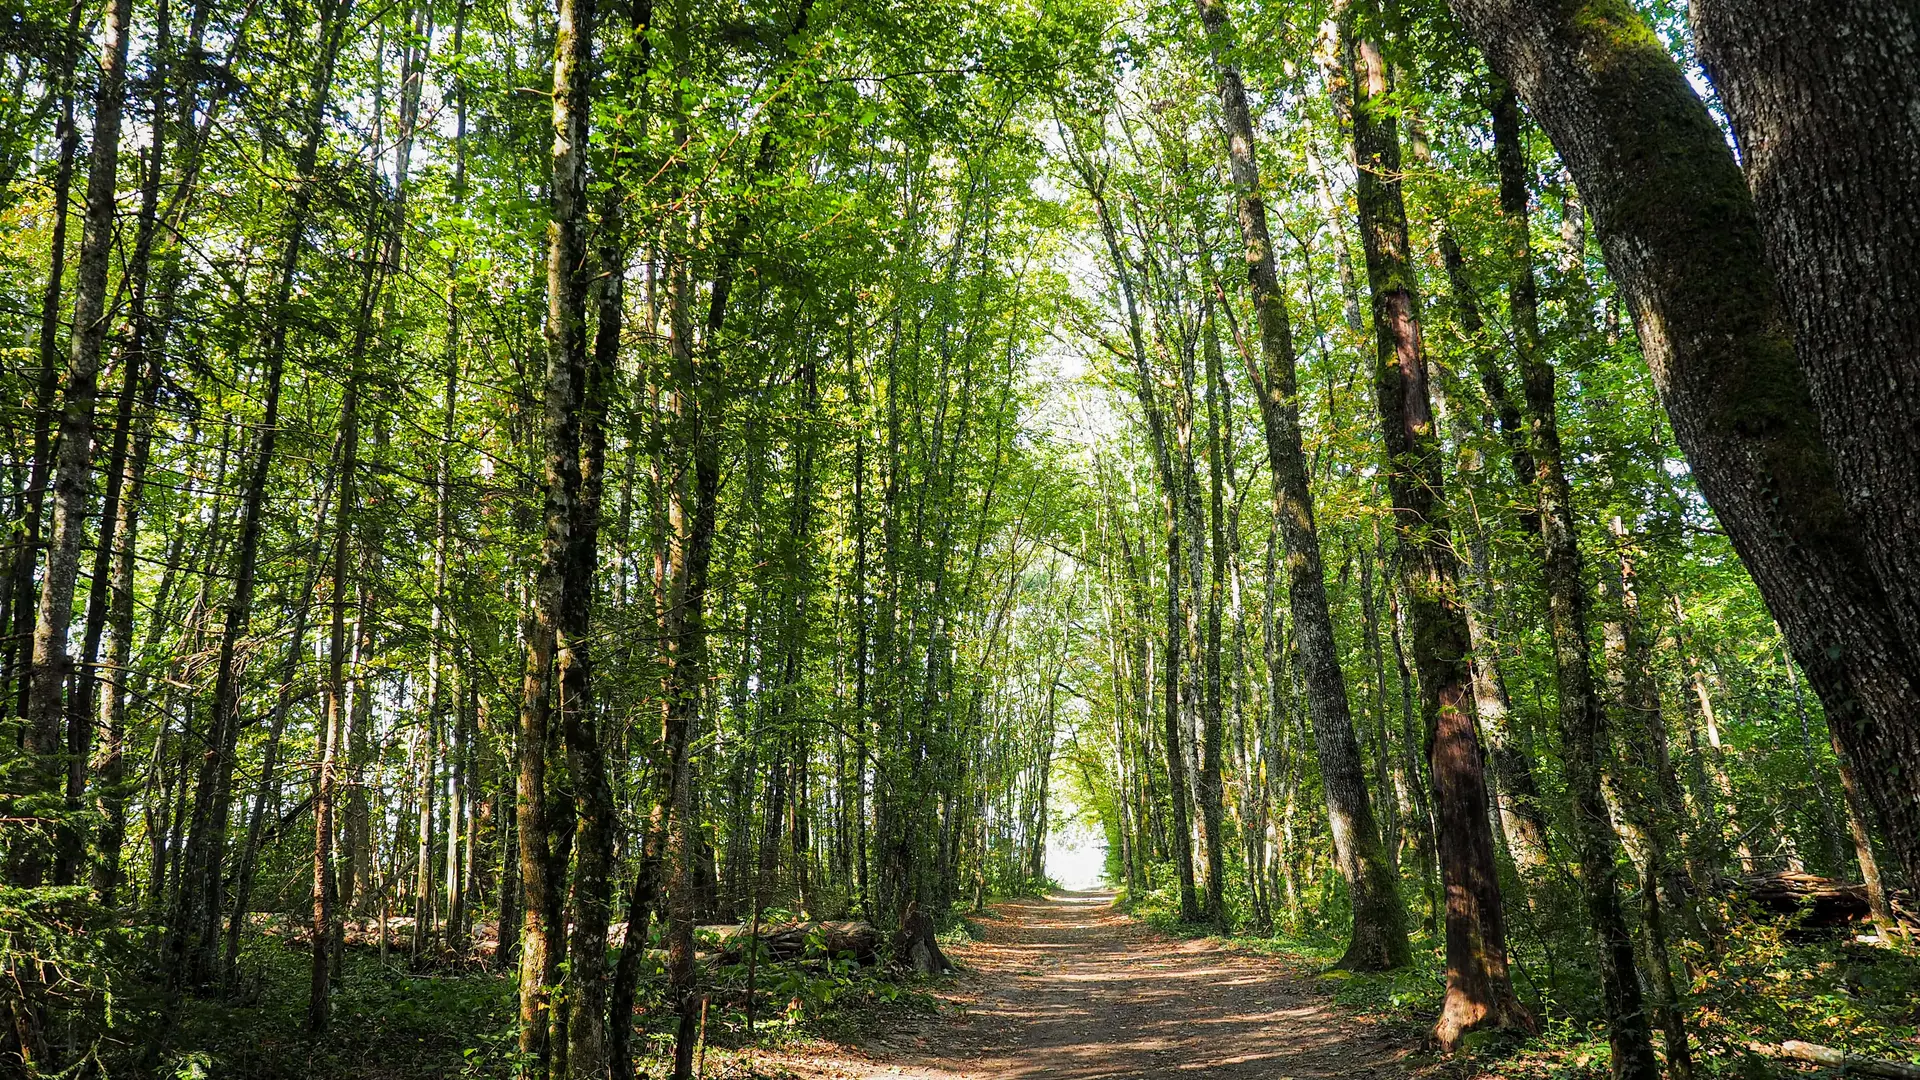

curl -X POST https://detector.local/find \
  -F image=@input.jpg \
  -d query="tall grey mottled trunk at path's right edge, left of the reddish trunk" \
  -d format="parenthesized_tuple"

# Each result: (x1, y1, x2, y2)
(1196, 0, 1413, 970)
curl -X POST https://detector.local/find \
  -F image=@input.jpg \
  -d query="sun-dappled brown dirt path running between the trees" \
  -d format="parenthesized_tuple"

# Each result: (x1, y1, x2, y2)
(764, 894, 1411, 1080)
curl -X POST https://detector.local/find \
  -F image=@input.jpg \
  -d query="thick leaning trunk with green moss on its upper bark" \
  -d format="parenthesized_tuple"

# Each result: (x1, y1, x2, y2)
(1452, 0, 1920, 891)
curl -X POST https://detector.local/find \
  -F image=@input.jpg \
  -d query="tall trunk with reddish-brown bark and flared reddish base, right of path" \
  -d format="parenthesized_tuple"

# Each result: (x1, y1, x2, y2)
(1340, 0, 1532, 1051)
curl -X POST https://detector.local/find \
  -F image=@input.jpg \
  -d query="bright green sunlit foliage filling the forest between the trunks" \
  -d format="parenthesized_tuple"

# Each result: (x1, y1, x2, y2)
(0, 0, 1916, 1078)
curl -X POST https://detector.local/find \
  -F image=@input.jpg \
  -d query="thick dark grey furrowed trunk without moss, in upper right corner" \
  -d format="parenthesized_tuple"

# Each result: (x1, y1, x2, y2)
(1690, 0, 1920, 672)
